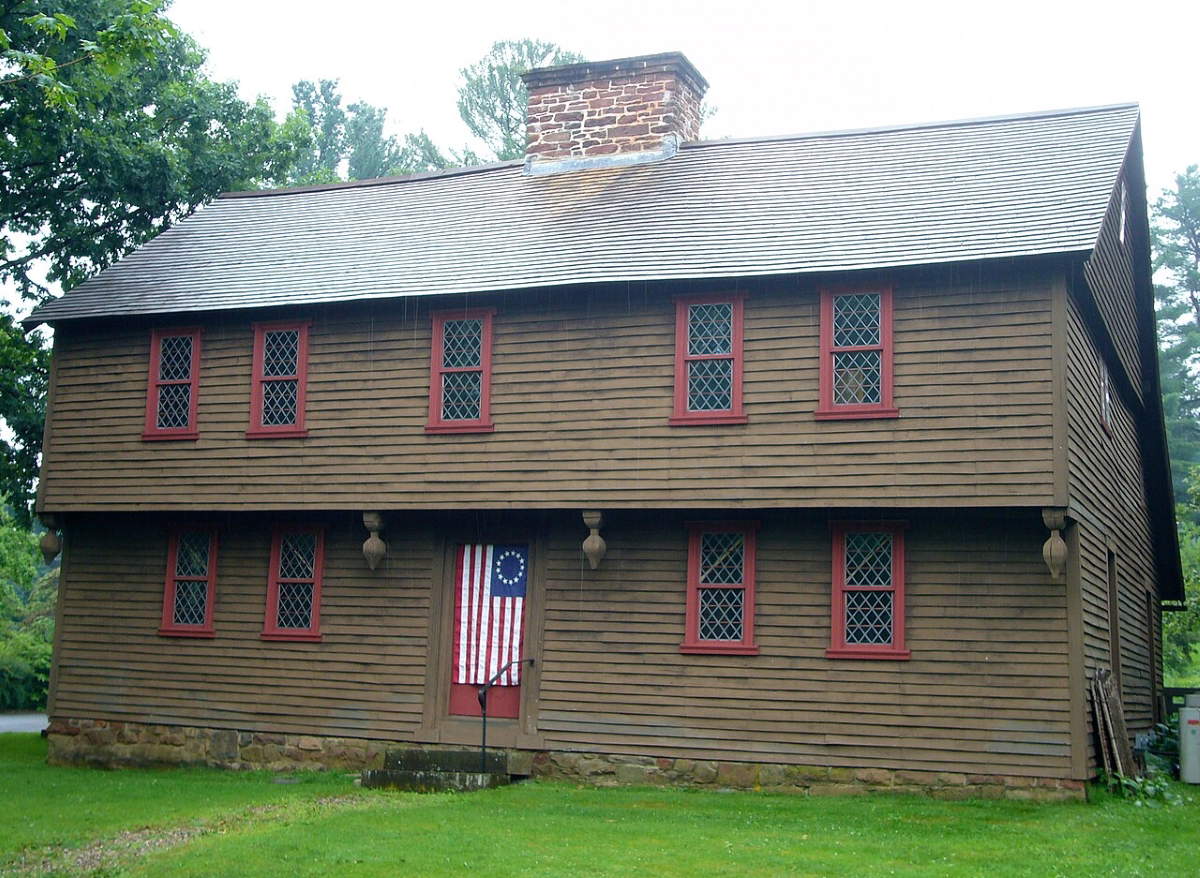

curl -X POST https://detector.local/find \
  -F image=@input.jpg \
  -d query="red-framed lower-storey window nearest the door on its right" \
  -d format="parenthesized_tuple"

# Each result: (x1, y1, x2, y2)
(679, 522, 758, 655)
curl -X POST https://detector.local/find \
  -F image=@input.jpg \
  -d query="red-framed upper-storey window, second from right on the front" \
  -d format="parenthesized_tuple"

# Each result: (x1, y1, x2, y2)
(671, 294, 746, 425)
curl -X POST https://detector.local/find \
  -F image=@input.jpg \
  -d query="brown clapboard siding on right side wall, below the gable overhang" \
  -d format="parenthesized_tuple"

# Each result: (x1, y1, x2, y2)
(1067, 301, 1159, 732)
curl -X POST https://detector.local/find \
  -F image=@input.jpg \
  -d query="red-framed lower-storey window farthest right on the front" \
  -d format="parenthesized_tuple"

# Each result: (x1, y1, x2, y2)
(826, 522, 911, 659)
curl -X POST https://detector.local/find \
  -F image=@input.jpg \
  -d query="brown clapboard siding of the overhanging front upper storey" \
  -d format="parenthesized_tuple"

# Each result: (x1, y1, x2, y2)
(42, 267, 1052, 511)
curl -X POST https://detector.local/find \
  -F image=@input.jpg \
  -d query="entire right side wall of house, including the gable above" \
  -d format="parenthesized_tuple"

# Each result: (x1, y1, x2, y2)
(1066, 183, 1162, 733)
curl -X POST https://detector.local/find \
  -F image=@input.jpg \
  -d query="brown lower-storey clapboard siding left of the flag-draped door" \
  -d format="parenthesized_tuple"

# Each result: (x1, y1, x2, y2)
(54, 516, 432, 738)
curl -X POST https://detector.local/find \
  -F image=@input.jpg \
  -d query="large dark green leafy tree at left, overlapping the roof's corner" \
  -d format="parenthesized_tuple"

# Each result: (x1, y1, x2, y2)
(0, 0, 307, 522)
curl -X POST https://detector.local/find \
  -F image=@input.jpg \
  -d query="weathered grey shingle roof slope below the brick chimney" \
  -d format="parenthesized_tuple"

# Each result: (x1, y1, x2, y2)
(26, 104, 1138, 323)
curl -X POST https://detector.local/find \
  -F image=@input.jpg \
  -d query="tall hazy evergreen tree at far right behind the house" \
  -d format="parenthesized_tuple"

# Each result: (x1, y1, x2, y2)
(1151, 166, 1200, 498)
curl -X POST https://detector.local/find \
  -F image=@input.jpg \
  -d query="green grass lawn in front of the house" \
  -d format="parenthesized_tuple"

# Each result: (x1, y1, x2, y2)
(0, 735, 1200, 878)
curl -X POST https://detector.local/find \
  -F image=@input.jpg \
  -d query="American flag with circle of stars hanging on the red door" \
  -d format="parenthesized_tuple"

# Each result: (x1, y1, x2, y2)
(454, 543, 529, 686)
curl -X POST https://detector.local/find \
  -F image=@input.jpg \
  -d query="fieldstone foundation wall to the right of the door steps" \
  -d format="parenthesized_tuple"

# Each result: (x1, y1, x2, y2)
(533, 752, 1084, 801)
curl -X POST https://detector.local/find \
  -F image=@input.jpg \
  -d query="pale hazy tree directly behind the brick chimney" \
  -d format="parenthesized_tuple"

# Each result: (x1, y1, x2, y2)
(458, 40, 586, 161)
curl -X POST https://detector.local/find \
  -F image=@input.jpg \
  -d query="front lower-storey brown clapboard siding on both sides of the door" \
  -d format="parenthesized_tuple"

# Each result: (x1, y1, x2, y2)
(54, 512, 1069, 777)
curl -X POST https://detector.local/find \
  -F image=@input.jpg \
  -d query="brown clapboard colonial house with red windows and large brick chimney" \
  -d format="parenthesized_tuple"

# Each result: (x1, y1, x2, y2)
(28, 54, 1182, 798)
